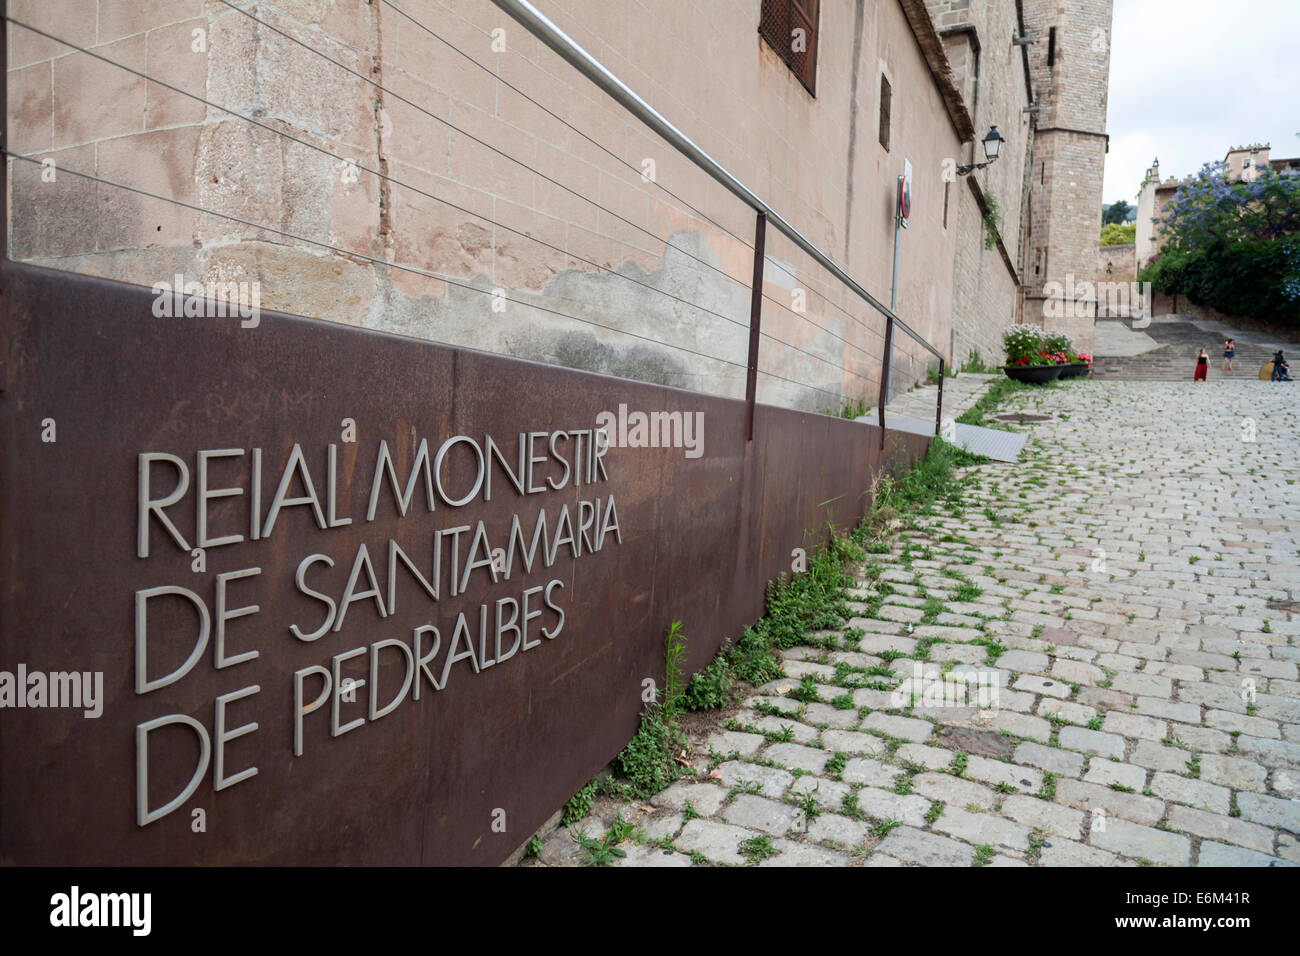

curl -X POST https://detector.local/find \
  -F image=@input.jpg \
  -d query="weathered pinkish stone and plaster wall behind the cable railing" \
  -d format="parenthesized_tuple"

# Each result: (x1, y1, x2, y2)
(8, 0, 1109, 400)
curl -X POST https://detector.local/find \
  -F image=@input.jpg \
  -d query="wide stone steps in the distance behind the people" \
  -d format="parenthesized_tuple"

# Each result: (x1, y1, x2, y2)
(1092, 315, 1300, 381)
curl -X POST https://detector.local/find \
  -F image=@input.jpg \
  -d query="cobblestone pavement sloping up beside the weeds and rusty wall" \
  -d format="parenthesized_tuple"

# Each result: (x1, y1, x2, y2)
(530, 380, 1300, 866)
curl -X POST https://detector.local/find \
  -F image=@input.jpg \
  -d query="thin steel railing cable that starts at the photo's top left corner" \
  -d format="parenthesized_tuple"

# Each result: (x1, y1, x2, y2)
(9, 18, 870, 390)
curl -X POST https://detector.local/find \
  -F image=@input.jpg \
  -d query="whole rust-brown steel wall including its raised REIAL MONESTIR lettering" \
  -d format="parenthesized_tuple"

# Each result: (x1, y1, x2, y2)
(0, 264, 928, 864)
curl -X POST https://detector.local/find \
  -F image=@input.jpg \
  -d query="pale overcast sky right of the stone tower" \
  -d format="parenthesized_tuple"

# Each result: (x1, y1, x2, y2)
(1104, 0, 1300, 206)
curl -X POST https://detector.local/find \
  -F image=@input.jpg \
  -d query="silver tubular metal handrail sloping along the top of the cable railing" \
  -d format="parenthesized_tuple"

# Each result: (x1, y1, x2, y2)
(493, 0, 944, 363)
